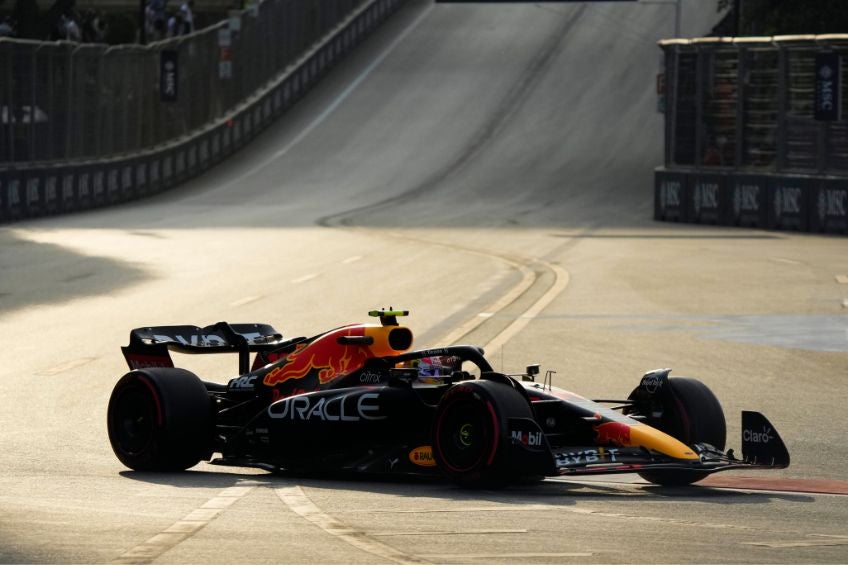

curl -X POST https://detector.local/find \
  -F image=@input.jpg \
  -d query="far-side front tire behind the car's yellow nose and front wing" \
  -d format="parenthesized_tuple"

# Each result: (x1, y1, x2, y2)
(639, 377, 727, 486)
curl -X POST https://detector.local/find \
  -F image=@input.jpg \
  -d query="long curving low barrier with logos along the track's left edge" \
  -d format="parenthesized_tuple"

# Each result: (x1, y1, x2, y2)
(0, 0, 405, 222)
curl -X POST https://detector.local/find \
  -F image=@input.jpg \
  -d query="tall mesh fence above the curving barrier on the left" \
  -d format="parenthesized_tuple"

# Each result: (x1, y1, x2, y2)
(0, 0, 366, 164)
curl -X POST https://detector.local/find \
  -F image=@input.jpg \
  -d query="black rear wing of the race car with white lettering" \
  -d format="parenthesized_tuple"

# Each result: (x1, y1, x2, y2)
(121, 322, 287, 374)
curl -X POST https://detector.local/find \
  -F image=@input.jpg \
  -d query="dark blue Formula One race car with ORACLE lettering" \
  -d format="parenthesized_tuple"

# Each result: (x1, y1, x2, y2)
(108, 310, 789, 486)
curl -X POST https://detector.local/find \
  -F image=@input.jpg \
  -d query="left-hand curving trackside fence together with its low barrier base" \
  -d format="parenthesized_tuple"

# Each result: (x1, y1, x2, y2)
(0, 0, 404, 222)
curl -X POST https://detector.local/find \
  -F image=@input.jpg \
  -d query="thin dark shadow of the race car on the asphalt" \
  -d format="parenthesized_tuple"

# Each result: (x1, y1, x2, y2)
(120, 470, 815, 506)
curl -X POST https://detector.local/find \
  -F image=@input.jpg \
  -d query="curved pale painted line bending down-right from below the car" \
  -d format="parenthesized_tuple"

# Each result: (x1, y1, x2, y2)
(274, 486, 430, 564)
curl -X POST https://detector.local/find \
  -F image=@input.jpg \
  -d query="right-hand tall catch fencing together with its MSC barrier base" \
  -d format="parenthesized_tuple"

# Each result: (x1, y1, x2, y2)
(654, 35, 848, 233)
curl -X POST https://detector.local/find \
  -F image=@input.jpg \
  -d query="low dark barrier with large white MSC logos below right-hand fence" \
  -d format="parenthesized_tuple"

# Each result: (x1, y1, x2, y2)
(654, 168, 848, 234)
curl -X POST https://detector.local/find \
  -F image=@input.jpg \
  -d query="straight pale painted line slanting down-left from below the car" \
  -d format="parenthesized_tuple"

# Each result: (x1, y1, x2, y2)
(112, 487, 255, 565)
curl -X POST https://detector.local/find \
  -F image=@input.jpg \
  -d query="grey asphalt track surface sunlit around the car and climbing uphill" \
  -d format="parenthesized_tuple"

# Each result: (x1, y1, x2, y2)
(0, 0, 848, 564)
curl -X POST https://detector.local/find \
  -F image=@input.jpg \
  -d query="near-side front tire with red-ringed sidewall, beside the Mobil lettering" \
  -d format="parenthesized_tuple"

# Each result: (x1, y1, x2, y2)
(432, 374, 533, 487)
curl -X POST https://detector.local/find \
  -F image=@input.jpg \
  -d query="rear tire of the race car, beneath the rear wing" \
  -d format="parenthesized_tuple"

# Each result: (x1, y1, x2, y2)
(107, 368, 213, 471)
